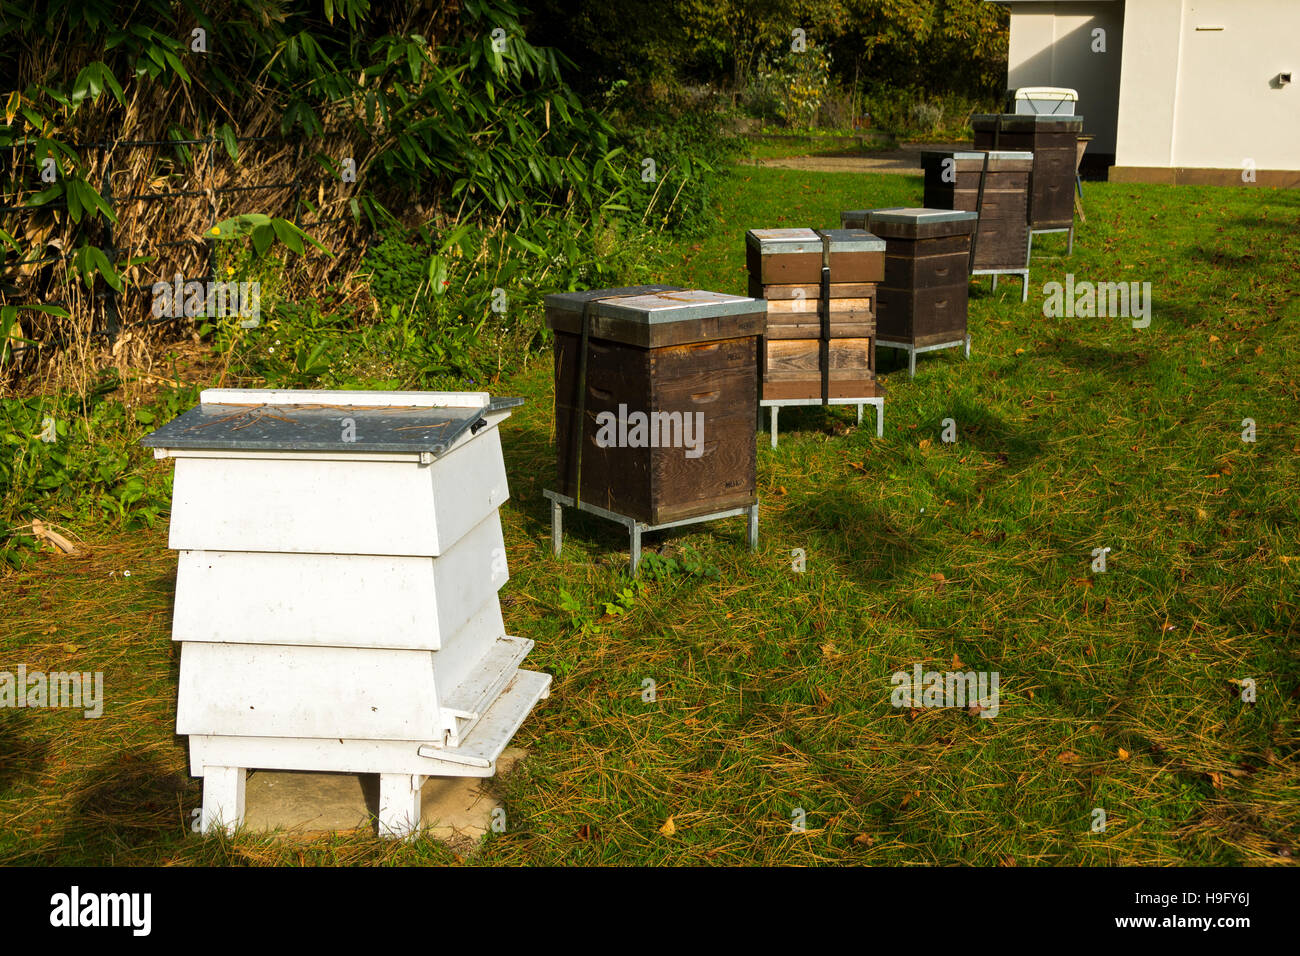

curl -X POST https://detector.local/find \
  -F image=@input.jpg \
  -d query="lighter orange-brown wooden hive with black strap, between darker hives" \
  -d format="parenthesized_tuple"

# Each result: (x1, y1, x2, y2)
(745, 229, 884, 402)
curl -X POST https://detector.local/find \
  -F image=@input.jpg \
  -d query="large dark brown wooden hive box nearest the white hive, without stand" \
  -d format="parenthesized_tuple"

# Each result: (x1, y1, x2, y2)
(546, 286, 767, 524)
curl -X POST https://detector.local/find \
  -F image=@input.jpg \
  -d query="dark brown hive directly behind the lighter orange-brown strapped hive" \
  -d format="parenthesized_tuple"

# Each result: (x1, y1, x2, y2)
(867, 208, 975, 347)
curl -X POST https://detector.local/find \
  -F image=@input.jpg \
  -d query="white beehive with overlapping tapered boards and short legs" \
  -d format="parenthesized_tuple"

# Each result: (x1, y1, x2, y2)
(142, 389, 551, 836)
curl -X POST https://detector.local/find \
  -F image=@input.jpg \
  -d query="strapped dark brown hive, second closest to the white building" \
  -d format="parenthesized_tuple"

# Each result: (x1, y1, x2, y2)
(920, 150, 1034, 271)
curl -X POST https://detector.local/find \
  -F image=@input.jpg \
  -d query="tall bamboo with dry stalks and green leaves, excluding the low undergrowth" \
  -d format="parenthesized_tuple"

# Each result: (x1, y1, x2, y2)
(0, 0, 629, 390)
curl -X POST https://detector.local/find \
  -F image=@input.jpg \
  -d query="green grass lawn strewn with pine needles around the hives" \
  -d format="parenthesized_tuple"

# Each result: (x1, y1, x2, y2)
(0, 168, 1300, 865)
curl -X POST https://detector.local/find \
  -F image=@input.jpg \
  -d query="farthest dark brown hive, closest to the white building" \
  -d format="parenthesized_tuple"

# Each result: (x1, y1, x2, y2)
(971, 113, 1083, 229)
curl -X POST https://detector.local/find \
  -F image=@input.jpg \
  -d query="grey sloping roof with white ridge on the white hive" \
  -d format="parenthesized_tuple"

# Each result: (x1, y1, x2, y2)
(140, 389, 524, 455)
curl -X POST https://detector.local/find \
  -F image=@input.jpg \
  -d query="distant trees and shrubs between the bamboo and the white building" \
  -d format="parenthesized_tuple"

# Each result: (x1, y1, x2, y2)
(533, 0, 1009, 137)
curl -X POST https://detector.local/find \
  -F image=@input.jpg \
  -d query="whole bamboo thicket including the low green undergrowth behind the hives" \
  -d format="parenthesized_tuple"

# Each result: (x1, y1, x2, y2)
(0, 0, 728, 559)
